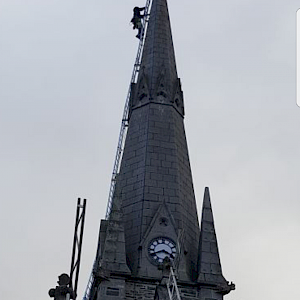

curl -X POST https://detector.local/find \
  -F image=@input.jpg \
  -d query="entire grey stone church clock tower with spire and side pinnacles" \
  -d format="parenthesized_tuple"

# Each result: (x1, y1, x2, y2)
(89, 0, 234, 300)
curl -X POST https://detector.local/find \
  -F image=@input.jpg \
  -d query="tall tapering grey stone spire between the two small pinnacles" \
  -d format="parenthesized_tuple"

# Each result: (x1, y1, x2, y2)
(117, 0, 199, 280)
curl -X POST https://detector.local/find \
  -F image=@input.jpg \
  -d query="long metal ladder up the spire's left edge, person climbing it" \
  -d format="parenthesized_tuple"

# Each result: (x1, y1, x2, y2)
(83, 0, 152, 300)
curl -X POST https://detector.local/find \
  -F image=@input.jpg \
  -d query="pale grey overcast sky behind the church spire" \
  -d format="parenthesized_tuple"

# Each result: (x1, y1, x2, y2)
(0, 0, 300, 300)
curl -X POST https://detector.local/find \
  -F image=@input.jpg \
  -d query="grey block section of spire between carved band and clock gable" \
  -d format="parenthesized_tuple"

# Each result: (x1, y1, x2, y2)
(118, 99, 199, 278)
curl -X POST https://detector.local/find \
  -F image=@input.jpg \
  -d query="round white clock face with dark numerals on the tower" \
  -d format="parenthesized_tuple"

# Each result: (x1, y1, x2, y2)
(148, 237, 176, 264)
